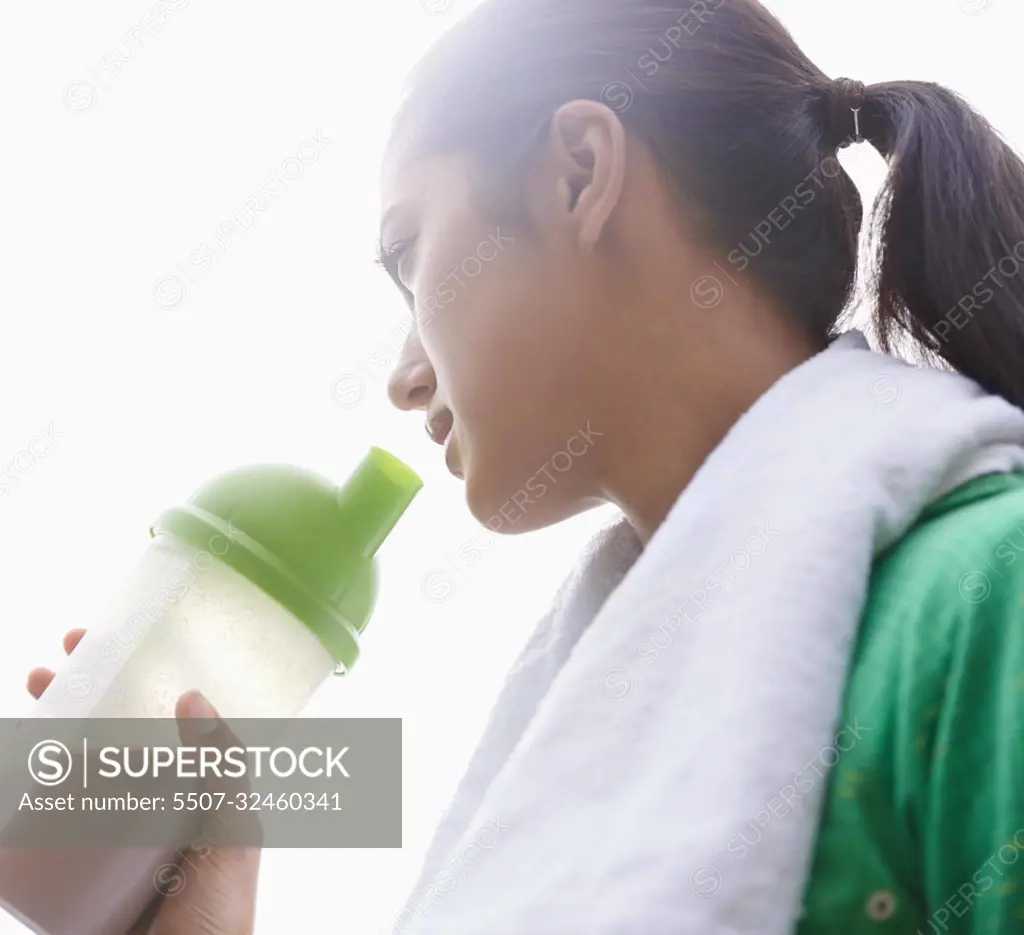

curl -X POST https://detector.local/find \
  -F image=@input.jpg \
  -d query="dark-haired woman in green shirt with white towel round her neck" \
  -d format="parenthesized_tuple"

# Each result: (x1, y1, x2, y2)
(24, 0, 1024, 935)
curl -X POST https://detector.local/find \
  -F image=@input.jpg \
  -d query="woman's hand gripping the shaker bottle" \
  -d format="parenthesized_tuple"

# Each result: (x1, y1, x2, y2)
(28, 630, 260, 935)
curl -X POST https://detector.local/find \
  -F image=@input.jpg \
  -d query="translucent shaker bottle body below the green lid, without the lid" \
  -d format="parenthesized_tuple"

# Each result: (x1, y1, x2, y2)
(0, 534, 336, 935)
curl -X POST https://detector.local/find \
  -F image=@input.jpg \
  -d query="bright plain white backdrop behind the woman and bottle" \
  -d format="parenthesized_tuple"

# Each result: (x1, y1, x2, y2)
(0, 0, 1024, 935)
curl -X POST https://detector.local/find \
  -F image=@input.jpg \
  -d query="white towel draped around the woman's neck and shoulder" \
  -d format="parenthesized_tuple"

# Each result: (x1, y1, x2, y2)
(392, 332, 1024, 935)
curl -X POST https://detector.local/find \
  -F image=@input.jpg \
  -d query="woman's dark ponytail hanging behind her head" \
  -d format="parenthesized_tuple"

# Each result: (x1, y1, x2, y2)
(860, 82, 1024, 408)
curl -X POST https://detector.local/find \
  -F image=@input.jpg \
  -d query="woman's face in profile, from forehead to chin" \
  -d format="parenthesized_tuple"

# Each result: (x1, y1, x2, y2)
(381, 119, 608, 533)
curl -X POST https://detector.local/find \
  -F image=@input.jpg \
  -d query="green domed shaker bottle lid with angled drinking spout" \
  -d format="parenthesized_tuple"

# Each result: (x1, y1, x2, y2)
(150, 448, 423, 674)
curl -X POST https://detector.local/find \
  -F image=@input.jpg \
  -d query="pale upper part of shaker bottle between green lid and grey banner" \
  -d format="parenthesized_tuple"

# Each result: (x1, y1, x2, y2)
(32, 534, 335, 719)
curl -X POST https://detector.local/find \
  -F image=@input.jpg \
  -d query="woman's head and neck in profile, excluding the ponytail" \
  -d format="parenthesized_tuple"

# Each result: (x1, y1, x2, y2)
(380, 0, 880, 537)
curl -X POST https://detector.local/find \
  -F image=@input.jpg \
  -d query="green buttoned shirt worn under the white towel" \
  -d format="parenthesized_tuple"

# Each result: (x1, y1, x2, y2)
(798, 474, 1024, 935)
